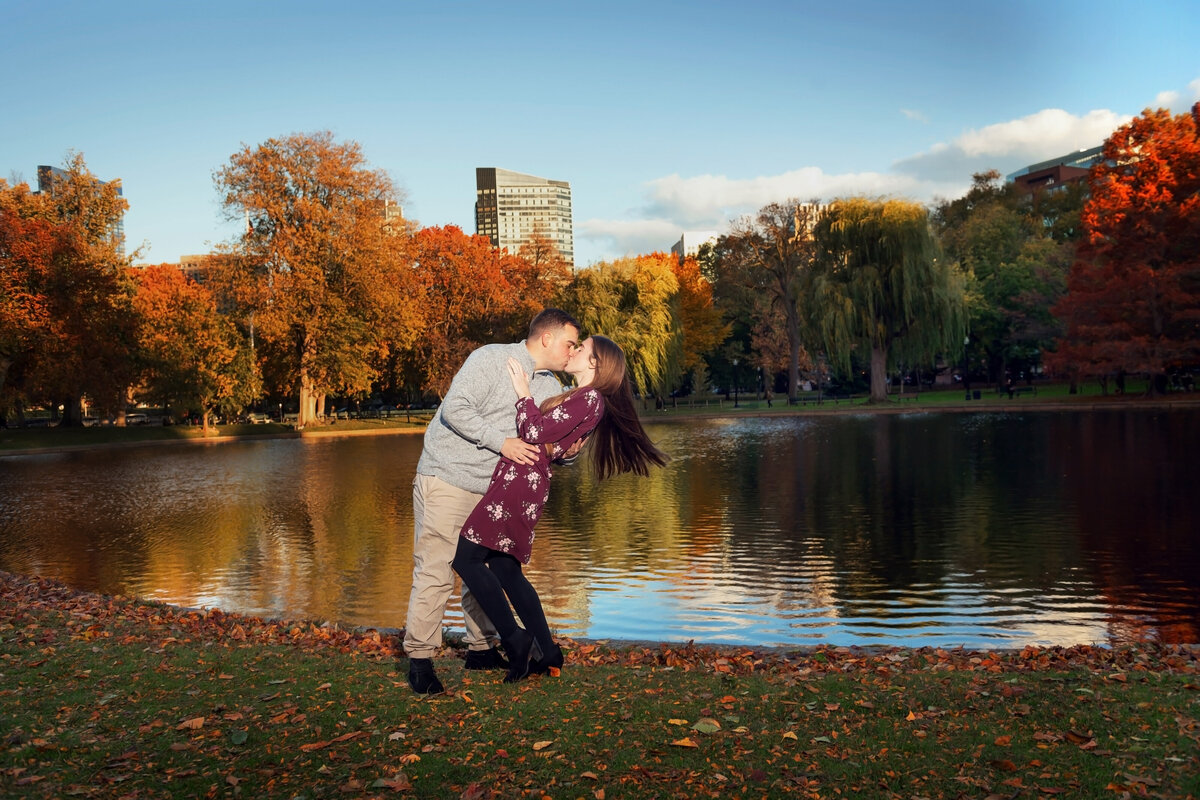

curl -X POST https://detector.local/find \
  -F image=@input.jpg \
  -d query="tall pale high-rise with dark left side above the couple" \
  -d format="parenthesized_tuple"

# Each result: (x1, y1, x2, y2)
(475, 167, 575, 267)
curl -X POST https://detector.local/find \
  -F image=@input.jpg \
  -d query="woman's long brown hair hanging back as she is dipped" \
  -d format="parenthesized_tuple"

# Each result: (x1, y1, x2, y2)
(541, 335, 667, 481)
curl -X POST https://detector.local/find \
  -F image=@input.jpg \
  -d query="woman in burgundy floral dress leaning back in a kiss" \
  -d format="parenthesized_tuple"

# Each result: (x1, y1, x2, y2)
(454, 336, 666, 682)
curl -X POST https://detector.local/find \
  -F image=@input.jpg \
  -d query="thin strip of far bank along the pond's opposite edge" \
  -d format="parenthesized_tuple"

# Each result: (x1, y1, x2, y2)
(7, 393, 1200, 458)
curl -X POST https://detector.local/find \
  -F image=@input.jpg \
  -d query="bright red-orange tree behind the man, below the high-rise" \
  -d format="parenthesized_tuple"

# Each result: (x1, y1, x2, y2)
(407, 225, 554, 396)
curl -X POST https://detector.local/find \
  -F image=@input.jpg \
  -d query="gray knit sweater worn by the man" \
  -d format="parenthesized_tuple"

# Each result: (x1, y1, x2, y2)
(416, 341, 564, 494)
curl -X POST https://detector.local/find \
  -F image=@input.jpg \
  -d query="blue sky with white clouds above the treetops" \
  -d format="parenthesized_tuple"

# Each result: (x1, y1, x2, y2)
(0, 0, 1200, 266)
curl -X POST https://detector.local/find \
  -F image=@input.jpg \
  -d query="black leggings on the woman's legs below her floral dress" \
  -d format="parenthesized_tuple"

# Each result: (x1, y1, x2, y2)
(454, 536, 553, 652)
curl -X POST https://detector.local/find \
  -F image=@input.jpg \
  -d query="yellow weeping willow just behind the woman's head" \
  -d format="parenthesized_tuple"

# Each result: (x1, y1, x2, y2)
(559, 253, 683, 398)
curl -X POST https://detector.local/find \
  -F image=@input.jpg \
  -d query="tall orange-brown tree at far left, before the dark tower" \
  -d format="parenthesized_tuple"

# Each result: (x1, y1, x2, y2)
(0, 154, 136, 426)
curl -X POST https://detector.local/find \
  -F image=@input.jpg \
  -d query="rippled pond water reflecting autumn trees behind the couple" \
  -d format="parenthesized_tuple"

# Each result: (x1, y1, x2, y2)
(0, 411, 1200, 646)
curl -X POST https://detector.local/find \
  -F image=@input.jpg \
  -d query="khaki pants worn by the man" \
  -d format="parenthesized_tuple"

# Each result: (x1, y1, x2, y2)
(404, 475, 498, 658)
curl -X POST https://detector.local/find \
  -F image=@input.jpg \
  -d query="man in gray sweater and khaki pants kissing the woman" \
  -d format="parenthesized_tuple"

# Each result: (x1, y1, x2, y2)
(404, 308, 580, 694)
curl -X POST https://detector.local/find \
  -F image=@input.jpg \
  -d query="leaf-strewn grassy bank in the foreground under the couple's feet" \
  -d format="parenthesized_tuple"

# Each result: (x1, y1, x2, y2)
(0, 573, 1200, 800)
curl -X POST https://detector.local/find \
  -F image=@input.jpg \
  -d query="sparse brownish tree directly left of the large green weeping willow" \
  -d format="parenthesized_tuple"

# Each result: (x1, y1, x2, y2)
(712, 199, 817, 402)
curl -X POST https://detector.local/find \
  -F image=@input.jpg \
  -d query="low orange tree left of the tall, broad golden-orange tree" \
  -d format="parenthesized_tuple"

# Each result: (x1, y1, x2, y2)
(133, 264, 259, 433)
